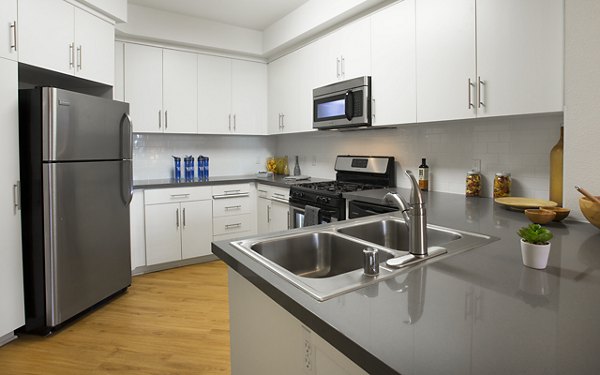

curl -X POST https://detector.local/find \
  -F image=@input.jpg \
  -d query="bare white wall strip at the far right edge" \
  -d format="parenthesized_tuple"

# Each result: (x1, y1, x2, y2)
(563, 0, 600, 220)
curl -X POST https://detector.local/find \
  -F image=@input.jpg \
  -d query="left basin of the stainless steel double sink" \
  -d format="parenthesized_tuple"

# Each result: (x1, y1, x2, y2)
(250, 232, 394, 278)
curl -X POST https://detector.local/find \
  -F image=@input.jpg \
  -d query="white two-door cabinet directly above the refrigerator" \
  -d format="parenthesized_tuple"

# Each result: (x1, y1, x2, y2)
(17, 0, 114, 85)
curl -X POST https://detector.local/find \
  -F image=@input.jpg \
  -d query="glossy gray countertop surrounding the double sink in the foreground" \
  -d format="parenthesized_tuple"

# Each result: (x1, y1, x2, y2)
(213, 189, 600, 374)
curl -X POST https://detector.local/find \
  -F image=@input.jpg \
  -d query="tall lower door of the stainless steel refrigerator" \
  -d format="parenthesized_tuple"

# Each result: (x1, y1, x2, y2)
(43, 161, 131, 327)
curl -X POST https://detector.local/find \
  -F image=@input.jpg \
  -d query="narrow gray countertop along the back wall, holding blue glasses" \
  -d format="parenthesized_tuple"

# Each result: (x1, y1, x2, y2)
(133, 175, 330, 189)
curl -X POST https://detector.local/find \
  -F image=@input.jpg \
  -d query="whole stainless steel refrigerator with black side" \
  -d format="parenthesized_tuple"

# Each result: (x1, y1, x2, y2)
(19, 87, 133, 334)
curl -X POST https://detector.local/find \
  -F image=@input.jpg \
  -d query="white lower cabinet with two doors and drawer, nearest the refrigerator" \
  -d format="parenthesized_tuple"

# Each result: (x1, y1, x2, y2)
(144, 187, 212, 266)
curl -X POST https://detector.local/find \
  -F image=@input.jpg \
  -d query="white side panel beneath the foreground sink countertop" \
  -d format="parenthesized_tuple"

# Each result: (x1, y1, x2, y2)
(229, 269, 366, 375)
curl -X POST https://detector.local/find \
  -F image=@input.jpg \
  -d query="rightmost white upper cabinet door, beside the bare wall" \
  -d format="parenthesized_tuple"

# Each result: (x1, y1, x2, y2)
(477, 0, 564, 117)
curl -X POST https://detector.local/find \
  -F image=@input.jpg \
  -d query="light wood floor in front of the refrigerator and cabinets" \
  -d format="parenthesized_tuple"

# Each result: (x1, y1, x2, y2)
(0, 261, 230, 375)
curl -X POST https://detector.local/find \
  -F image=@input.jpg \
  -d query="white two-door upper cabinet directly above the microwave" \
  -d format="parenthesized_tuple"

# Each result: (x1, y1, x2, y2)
(313, 17, 371, 86)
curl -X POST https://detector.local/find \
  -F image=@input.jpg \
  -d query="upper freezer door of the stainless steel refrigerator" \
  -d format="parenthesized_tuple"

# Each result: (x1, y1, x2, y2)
(41, 87, 131, 161)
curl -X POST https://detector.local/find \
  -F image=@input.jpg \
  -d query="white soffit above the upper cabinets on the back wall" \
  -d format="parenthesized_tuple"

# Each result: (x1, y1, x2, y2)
(117, 4, 263, 56)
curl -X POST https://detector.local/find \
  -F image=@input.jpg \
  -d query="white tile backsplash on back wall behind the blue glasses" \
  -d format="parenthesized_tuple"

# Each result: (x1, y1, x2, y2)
(133, 134, 275, 180)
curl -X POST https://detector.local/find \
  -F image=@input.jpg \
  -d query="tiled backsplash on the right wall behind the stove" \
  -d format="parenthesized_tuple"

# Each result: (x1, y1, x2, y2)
(277, 115, 562, 199)
